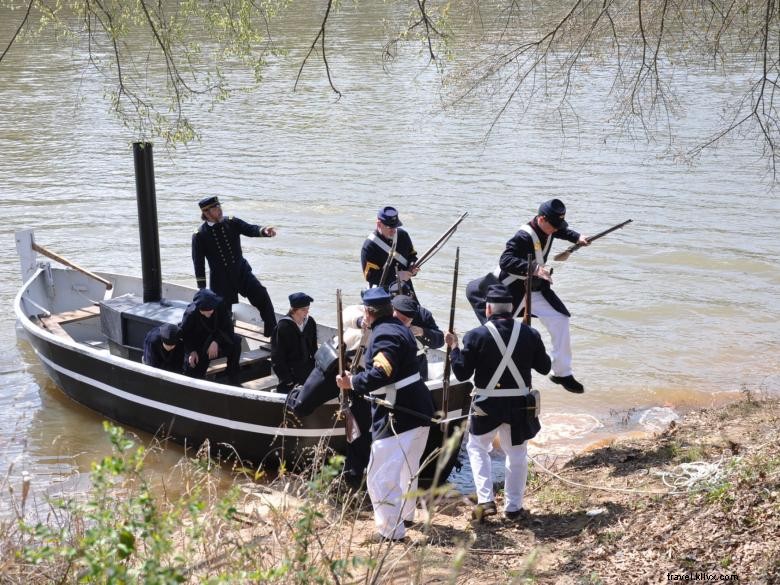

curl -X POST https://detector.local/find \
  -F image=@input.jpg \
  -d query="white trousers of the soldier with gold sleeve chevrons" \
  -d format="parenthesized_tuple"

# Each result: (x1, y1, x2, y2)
(366, 427, 428, 538)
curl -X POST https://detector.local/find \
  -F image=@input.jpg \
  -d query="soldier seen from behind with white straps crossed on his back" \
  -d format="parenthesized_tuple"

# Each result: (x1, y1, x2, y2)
(445, 284, 550, 521)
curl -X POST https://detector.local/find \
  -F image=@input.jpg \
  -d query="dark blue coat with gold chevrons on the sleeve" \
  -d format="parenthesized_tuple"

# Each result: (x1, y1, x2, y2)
(352, 317, 433, 440)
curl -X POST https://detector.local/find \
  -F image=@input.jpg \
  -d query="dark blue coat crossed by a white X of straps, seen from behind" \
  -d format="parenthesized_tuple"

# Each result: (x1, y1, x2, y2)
(450, 313, 551, 445)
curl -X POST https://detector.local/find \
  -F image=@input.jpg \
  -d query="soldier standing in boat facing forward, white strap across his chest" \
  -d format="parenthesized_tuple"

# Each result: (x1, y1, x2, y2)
(360, 207, 417, 286)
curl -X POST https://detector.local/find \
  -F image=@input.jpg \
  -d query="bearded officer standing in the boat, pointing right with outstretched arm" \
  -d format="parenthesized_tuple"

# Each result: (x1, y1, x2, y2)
(192, 196, 276, 337)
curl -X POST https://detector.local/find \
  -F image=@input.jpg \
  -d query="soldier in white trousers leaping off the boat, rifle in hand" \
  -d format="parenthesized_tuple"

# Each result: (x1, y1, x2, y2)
(466, 199, 589, 394)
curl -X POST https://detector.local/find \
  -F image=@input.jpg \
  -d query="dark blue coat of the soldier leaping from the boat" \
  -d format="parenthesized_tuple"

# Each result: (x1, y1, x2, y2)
(466, 218, 580, 323)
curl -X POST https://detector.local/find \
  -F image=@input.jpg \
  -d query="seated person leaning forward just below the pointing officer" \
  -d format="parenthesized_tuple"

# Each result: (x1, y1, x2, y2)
(181, 288, 241, 386)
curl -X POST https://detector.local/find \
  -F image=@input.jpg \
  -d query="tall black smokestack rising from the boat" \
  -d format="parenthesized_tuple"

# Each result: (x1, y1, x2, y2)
(133, 142, 162, 303)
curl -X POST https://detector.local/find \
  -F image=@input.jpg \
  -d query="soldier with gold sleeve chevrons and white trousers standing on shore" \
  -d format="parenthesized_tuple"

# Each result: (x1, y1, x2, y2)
(336, 288, 433, 540)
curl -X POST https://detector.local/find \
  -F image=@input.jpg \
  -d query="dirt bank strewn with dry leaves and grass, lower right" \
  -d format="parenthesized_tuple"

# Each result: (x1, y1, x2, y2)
(324, 394, 780, 585)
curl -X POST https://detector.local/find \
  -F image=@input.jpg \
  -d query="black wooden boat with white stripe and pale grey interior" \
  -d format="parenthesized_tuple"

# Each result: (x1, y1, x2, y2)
(14, 228, 472, 477)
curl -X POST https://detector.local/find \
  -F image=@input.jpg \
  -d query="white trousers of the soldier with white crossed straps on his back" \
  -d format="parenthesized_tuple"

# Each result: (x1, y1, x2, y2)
(466, 423, 528, 512)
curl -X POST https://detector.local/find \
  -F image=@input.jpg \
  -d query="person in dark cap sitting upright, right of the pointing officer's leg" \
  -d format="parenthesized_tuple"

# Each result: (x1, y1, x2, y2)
(271, 292, 317, 393)
